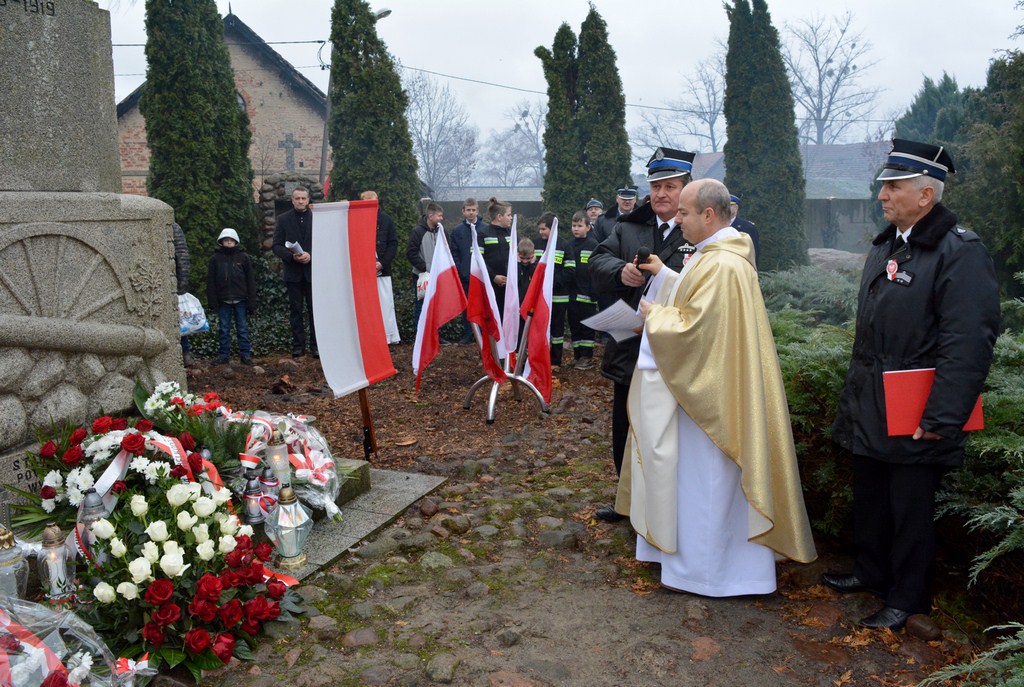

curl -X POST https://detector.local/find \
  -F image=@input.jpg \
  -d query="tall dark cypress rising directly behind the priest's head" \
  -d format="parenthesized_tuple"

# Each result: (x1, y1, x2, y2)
(724, 0, 808, 270)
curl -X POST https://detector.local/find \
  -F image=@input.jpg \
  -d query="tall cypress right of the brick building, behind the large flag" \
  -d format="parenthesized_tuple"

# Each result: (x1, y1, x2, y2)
(329, 0, 420, 236)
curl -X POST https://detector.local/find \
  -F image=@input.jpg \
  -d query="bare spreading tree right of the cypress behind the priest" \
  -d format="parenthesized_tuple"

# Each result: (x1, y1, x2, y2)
(782, 12, 880, 144)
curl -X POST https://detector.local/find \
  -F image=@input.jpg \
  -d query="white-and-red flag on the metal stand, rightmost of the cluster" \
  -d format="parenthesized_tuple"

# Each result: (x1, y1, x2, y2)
(521, 217, 558, 403)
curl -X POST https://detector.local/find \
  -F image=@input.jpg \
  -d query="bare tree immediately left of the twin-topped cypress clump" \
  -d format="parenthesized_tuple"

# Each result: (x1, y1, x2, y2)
(482, 100, 548, 186)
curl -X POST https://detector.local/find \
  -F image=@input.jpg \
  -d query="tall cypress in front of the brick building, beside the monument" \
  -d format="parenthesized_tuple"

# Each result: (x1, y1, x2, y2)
(139, 0, 259, 285)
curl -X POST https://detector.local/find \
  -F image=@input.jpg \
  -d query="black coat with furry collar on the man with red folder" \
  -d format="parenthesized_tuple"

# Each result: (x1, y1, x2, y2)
(833, 205, 999, 466)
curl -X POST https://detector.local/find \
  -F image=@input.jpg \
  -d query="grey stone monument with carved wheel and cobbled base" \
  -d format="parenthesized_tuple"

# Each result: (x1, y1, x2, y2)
(0, 0, 184, 516)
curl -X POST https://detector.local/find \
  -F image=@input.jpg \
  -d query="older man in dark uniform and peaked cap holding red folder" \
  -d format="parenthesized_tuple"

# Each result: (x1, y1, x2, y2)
(821, 139, 999, 630)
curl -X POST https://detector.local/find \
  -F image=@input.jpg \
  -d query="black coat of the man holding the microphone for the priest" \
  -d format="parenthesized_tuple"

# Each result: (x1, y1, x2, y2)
(590, 203, 694, 385)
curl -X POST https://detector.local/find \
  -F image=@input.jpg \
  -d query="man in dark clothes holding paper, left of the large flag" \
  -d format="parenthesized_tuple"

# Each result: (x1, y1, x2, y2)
(273, 186, 319, 357)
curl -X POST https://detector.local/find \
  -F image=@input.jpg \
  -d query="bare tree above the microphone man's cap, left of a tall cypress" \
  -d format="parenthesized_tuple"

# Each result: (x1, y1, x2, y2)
(630, 50, 725, 157)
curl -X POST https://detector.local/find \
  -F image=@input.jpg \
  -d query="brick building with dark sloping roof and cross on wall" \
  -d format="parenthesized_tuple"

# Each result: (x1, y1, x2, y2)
(117, 13, 330, 196)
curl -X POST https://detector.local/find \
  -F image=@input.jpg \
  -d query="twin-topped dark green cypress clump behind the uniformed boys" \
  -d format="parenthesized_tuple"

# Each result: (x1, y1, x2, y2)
(534, 5, 632, 222)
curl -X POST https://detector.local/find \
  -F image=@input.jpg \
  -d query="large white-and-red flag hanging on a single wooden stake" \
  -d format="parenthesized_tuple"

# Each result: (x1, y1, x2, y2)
(303, 201, 396, 398)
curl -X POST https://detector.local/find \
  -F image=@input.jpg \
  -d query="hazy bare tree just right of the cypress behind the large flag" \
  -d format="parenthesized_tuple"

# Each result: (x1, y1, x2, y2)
(404, 73, 478, 194)
